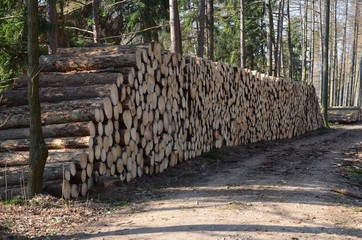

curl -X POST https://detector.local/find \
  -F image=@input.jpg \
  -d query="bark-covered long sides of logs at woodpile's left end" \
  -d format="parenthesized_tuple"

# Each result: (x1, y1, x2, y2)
(0, 46, 140, 199)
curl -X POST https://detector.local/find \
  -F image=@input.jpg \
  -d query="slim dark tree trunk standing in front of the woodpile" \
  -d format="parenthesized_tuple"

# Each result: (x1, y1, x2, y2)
(27, 0, 48, 196)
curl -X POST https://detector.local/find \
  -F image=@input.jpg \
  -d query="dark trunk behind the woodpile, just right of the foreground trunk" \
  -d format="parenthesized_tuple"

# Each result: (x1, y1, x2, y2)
(46, 0, 58, 54)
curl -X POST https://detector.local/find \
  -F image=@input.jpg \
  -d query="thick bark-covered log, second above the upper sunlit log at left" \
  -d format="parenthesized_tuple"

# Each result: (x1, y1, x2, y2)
(0, 98, 102, 129)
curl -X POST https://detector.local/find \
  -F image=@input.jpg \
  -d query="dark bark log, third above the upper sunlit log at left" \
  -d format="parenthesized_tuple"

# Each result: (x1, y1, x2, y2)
(0, 84, 111, 107)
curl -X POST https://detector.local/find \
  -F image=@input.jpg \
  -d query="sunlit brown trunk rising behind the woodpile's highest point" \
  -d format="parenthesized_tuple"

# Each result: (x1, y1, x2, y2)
(169, 0, 182, 54)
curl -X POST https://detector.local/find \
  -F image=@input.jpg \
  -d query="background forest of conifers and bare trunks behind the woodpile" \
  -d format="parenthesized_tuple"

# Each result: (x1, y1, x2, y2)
(0, 0, 362, 106)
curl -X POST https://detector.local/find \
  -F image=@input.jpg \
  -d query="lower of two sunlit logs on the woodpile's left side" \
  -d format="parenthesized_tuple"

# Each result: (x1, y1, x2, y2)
(0, 149, 84, 167)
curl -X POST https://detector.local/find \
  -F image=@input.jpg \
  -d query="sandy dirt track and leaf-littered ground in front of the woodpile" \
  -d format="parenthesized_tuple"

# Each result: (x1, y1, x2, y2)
(0, 124, 362, 240)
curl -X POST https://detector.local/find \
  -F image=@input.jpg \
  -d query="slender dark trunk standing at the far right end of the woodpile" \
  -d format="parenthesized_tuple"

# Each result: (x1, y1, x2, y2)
(322, 0, 331, 124)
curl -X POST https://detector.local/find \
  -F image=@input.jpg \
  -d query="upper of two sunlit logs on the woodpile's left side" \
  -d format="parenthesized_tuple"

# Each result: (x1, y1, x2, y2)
(0, 136, 89, 152)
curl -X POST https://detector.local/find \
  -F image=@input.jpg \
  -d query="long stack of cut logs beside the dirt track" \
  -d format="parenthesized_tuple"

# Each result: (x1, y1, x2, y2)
(0, 43, 323, 199)
